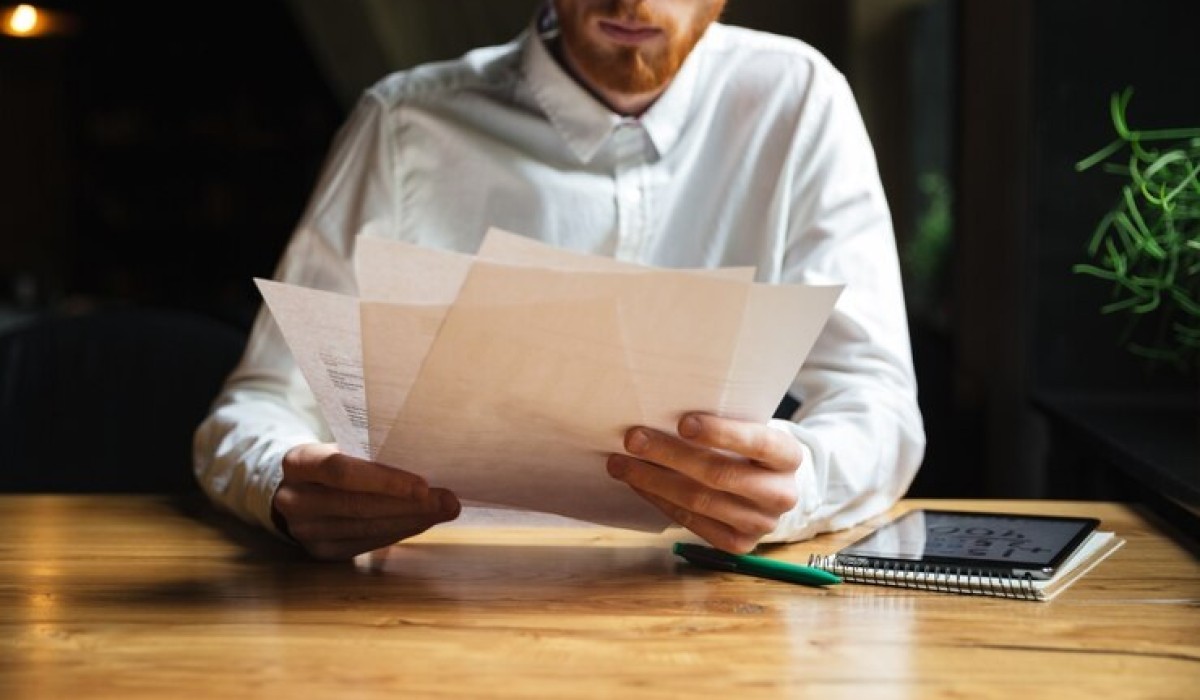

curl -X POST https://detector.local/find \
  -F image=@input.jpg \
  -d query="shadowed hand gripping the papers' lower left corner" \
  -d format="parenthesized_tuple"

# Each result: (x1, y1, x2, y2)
(271, 444, 462, 560)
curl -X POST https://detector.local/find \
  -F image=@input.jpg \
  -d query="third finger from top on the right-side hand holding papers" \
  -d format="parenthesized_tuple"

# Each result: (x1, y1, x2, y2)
(608, 455, 776, 537)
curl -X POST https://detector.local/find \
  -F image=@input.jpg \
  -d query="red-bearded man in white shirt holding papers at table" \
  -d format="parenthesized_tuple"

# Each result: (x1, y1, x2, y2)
(196, 0, 924, 560)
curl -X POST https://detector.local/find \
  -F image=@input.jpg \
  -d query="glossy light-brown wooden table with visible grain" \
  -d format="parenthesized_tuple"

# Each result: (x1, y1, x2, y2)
(0, 496, 1200, 700)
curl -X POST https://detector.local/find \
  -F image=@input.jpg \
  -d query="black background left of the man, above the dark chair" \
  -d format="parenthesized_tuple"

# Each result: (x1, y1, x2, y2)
(0, 0, 342, 325)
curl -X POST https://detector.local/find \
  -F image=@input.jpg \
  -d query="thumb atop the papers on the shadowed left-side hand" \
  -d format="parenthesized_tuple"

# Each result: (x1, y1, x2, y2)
(283, 445, 428, 499)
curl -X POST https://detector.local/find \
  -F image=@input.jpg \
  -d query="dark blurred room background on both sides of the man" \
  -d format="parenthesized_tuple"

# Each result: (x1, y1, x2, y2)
(0, 0, 1200, 511)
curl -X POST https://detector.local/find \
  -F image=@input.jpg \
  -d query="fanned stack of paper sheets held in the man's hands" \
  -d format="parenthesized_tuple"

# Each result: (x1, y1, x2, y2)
(257, 229, 841, 531)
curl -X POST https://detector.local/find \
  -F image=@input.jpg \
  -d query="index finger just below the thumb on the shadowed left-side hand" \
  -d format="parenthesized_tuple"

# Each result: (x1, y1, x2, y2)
(272, 484, 461, 522)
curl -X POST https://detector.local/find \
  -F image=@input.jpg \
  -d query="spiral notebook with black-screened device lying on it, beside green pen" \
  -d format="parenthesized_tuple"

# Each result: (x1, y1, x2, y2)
(809, 509, 1124, 600)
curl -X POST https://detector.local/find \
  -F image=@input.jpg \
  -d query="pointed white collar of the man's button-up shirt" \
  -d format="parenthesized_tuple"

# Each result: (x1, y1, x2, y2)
(522, 7, 715, 162)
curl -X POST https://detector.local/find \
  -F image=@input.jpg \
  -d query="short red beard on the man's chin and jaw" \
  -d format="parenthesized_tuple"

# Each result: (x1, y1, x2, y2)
(559, 0, 725, 95)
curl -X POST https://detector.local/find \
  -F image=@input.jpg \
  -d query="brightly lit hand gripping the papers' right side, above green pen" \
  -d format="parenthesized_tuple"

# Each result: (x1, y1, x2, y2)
(608, 413, 804, 554)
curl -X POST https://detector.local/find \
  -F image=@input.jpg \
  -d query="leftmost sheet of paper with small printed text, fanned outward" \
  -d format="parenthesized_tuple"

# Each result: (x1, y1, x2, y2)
(254, 280, 370, 456)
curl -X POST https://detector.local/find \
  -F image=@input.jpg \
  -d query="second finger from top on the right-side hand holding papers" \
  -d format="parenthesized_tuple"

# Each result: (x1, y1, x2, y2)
(625, 427, 798, 514)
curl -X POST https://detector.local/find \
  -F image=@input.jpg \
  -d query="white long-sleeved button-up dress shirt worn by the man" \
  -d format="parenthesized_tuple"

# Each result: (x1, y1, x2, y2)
(194, 15, 925, 540)
